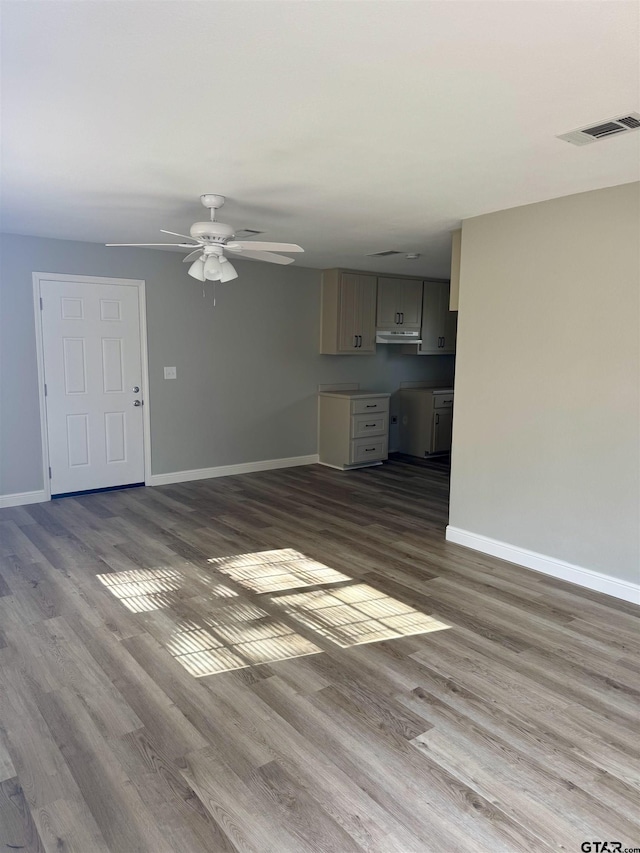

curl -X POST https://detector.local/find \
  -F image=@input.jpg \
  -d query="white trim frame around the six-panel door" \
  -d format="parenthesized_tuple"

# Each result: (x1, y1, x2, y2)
(32, 272, 151, 501)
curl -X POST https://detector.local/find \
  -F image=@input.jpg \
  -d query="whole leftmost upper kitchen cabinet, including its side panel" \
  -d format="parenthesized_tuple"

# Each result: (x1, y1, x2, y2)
(320, 270, 376, 355)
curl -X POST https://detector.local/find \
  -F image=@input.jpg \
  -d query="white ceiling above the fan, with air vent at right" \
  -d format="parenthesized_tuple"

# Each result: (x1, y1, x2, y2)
(2, 0, 640, 276)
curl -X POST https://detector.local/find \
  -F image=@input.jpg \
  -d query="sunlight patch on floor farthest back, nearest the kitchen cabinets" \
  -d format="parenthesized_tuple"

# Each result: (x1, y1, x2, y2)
(208, 548, 351, 593)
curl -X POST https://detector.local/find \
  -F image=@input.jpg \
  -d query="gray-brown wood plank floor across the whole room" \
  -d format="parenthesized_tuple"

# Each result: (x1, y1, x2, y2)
(0, 460, 640, 853)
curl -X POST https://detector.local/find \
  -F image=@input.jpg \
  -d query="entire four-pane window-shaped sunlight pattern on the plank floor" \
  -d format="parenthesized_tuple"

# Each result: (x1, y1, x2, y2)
(97, 548, 449, 678)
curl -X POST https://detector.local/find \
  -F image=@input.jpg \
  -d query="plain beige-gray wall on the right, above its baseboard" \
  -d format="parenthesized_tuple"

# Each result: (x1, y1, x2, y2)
(450, 184, 640, 581)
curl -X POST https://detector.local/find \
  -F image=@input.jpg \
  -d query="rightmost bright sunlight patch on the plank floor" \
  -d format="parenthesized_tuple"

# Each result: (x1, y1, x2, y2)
(272, 583, 450, 648)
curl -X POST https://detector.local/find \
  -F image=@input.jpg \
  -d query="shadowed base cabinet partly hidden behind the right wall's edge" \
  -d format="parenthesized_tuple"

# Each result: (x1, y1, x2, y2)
(398, 388, 453, 458)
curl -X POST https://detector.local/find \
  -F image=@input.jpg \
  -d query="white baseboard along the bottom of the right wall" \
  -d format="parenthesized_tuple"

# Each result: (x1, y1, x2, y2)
(446, 525, 640, 604)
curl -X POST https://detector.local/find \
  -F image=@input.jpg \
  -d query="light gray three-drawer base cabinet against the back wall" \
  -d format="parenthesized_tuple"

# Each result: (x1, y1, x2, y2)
(318, 391, 391, 471)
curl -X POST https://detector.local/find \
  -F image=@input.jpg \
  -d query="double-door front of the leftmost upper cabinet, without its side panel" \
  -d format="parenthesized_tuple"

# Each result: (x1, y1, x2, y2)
(338, 273, 376, 355)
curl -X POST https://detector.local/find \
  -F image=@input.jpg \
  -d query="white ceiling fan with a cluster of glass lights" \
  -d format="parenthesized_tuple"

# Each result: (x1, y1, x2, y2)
(106, 193, 304, 281)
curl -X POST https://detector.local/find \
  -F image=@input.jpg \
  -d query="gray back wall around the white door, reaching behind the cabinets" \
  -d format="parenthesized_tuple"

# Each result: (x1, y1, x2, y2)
(0, 235, 453, 494)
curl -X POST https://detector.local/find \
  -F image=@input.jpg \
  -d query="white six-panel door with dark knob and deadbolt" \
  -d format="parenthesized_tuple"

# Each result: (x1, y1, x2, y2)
(40, 281, 144, 495)
